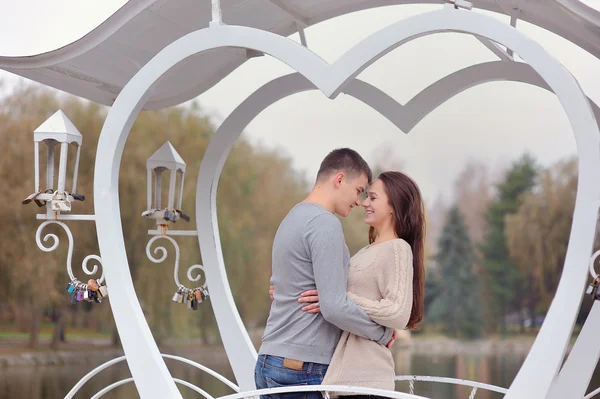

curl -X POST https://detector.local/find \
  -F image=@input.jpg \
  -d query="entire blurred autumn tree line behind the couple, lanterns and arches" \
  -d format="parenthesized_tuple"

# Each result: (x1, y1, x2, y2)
(0, 85, 589, 348)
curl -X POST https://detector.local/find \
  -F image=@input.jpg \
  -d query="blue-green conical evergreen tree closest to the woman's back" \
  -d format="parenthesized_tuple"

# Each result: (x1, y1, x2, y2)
(431, 205, 482, 338)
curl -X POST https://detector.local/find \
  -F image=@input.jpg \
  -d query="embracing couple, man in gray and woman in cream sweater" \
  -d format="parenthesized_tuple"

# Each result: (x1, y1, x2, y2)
(255, 148, 425, 399)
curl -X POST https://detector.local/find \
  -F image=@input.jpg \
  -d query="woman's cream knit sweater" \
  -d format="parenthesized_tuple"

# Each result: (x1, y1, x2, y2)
(323, 239, 413, 396)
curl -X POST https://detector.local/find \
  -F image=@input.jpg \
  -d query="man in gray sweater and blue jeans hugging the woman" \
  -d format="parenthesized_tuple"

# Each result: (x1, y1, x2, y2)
(255, 148, 394, 399)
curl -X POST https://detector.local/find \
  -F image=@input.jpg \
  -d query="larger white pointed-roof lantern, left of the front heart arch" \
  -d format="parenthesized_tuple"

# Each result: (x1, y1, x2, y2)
(23, 110, 84, 213)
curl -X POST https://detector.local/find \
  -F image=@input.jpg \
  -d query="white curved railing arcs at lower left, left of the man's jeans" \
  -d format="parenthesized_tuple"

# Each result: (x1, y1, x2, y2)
(65, 354, 240, 399)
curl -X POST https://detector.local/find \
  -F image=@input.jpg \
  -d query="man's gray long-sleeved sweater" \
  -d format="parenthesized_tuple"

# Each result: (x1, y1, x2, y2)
(259, 202, 393, 364)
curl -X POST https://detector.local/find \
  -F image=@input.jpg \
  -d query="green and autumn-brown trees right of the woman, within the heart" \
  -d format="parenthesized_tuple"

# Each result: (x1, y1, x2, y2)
(425, 154, 600, 338)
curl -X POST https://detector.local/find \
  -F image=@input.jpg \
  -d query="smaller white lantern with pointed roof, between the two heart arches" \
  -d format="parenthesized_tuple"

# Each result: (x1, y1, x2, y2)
(142, 141, 190, 226)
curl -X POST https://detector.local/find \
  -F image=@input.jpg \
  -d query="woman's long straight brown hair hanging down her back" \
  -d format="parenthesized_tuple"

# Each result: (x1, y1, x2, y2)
(369, 172, 425, 330)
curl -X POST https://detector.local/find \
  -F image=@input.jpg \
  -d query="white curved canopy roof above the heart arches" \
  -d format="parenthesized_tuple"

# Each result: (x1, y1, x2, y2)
(0, 0, 600, 109)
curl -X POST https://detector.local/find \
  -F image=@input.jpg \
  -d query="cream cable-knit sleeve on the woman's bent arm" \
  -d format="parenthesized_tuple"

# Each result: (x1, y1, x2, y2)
(348, 240, 413, 329)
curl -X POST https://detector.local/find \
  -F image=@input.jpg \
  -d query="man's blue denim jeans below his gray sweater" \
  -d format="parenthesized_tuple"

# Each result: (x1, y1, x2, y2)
(254, 355, 328, 399)
